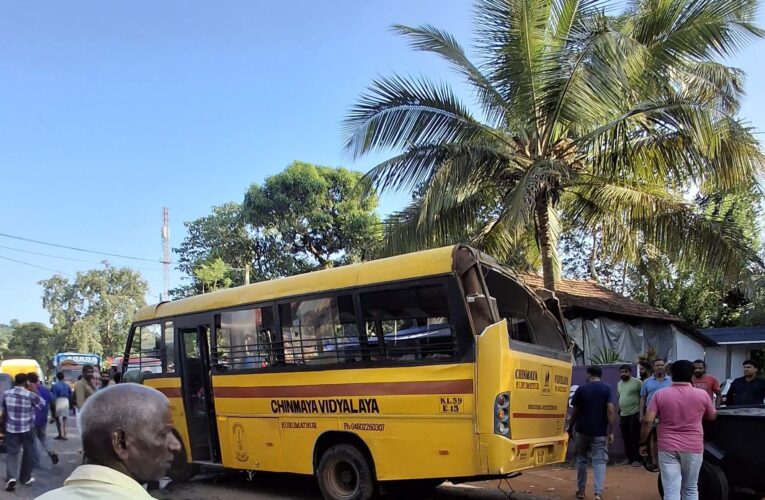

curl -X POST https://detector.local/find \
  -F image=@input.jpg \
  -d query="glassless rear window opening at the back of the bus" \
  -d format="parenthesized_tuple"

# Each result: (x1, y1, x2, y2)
(485, 269, 566, 351)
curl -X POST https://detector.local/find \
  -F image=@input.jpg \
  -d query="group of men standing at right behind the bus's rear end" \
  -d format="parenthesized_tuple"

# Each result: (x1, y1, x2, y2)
(568, 359, 765, 500)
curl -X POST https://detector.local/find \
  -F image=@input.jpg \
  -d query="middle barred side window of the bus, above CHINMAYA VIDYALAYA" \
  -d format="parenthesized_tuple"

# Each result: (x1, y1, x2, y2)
(279, 295, 361, 365)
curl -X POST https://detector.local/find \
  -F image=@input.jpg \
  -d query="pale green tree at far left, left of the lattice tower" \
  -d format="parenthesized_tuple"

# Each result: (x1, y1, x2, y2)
(40, 264, 149, 355)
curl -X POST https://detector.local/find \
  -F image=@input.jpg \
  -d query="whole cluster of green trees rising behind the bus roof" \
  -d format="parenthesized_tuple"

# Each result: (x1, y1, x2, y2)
(171, 161, 381, 298)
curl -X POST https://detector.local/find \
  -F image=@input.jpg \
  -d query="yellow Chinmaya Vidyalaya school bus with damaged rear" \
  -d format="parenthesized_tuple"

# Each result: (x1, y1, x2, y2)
(123, 246, 571, 499)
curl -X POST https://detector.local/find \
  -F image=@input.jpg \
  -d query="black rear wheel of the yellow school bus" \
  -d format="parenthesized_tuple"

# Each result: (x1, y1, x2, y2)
(317, 444, 377, 500)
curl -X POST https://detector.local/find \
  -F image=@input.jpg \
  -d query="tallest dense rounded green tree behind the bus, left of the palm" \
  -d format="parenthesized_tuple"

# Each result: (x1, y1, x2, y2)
(244, 162, 380, 269)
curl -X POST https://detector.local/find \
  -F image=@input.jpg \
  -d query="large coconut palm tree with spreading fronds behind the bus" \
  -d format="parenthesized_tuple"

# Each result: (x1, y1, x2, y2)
(344, 0, 765, 290)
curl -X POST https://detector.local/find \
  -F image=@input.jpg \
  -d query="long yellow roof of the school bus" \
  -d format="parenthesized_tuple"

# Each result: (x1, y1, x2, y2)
(134, 245, 457, 322)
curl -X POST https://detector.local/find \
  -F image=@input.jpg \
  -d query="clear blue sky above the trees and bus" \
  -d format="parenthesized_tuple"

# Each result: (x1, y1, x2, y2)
(0, 0, 765, 322)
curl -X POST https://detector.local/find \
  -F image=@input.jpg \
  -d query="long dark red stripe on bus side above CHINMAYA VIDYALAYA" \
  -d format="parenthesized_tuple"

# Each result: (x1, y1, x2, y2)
(213, 379, 473, 398)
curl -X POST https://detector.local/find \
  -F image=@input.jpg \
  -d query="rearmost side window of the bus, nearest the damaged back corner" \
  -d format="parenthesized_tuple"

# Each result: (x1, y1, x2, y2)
(361, 285, 457, 361)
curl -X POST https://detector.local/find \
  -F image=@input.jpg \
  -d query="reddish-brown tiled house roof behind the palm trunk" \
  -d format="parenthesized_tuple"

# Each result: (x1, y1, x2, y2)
(520, 274, 685, 323)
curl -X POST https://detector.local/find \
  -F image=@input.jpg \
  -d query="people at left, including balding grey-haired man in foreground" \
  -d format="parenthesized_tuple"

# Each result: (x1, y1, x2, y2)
(2, 366, 181, 500)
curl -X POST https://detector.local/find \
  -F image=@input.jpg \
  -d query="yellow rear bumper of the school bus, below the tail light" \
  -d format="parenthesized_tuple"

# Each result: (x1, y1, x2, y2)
(479, 434, 568, 475)
